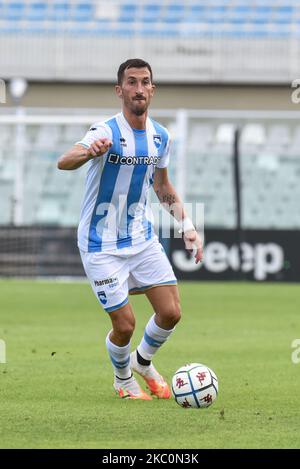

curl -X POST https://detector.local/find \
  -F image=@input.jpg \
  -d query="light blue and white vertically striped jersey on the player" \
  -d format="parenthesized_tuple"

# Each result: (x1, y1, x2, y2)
(77, 113, 170, 252)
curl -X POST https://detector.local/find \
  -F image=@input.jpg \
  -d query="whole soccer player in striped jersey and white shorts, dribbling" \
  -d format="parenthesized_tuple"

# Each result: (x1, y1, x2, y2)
(58, 59, 202, 400)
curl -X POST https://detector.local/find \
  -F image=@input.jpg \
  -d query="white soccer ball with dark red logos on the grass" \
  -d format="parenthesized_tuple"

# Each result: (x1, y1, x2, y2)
(172, 363, 218, 409)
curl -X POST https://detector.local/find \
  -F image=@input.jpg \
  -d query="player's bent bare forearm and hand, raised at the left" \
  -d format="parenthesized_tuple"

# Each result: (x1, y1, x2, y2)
(57, 138, 112, 170)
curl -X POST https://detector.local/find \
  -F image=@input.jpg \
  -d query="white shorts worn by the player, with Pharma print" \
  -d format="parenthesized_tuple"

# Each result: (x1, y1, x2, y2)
(80, 238, 177, 313)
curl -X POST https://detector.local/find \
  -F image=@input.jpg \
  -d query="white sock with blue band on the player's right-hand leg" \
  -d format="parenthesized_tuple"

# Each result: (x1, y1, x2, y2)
(137, 314, 175, 360)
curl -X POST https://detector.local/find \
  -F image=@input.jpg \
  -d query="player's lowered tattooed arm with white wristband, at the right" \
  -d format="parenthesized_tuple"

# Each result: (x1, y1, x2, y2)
(153, 168, 203, 264)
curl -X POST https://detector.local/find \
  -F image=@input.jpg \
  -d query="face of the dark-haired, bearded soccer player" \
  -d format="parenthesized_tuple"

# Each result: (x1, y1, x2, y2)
(116, 67, 154, 116)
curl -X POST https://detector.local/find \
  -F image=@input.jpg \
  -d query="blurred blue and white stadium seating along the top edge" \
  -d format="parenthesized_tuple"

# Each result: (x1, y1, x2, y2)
(0, 0, 300, 38)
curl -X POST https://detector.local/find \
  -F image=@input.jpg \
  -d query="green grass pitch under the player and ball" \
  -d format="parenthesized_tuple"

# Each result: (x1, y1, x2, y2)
(0, 280, 300, 449)
